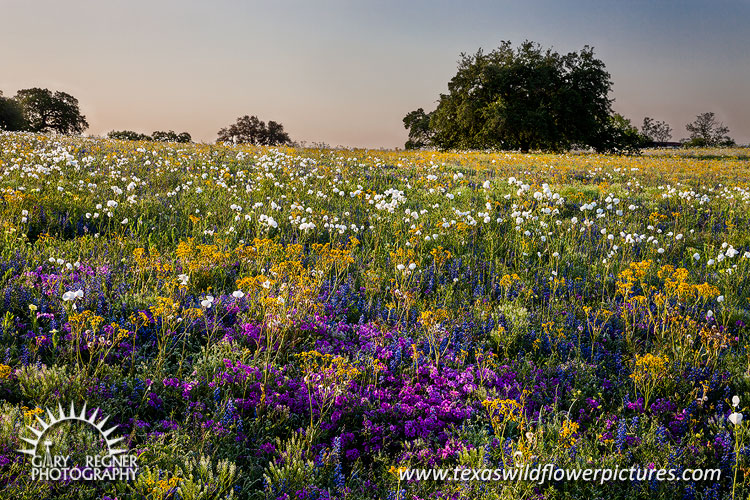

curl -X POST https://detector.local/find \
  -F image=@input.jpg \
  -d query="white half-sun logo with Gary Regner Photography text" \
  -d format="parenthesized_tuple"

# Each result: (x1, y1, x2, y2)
(18, 403, 137, 481)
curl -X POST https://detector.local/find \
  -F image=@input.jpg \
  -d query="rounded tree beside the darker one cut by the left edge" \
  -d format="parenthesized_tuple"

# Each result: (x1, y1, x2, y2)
(15, 88, 89, 134)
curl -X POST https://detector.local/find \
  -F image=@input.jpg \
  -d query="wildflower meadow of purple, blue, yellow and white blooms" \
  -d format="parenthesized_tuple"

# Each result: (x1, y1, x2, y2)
(0, 134, 750, 499)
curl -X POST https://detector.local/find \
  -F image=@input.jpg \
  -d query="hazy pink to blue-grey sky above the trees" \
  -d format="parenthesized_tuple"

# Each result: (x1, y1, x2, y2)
(0, 0, 750, 148)
